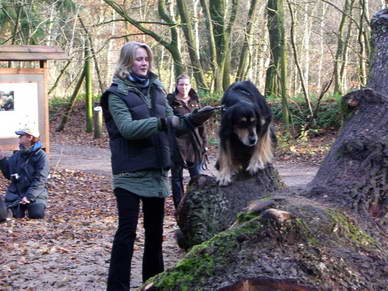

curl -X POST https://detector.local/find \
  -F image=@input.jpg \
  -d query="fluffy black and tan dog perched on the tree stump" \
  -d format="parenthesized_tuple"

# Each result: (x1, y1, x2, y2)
(216, 81, 275, 186)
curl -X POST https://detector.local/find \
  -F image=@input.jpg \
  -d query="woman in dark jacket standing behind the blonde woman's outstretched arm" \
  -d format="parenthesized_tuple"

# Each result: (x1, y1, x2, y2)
(167, 74, 207, 209)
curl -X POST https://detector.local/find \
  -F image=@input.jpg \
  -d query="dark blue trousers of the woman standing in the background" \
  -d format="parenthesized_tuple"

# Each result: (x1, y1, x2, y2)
(171, 162, 200, 209)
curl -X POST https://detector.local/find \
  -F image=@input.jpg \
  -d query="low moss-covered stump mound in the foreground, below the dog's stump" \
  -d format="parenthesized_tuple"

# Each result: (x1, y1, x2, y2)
(142, 193, 388, 291)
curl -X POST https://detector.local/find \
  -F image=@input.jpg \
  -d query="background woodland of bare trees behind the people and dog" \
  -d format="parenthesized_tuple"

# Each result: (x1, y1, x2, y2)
(0, 0, 387, 135)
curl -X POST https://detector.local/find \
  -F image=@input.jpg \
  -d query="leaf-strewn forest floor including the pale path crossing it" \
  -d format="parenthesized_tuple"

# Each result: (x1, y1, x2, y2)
(0, 106, 335, 291)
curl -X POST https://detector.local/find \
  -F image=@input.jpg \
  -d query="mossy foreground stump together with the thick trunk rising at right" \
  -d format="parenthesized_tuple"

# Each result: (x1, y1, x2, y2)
(142, 9, 388, 291)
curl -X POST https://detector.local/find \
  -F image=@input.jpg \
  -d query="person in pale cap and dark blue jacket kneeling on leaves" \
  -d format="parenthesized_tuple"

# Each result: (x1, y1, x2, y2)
(0, 128, 49, 219)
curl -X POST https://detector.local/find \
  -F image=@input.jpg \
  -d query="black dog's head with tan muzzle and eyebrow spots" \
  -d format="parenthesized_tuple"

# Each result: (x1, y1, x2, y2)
(221, 102, 261, 147)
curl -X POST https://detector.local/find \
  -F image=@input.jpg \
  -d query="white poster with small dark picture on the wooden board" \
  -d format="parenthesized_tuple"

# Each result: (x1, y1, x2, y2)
(0, 83, 39, 138)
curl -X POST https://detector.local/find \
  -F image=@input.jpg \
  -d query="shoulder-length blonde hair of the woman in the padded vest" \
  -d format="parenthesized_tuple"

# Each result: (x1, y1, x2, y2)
(114, 41, 153, 79)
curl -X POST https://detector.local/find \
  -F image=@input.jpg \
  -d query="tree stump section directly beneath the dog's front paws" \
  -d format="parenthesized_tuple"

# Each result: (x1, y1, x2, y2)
(176, 165, 284, 249)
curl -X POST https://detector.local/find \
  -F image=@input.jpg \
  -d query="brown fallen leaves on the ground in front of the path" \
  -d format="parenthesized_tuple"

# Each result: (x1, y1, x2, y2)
(0, 170, 183, 290)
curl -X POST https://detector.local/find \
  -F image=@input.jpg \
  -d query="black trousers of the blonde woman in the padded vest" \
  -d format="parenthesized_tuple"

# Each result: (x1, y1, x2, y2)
(107, 188, 165, 291)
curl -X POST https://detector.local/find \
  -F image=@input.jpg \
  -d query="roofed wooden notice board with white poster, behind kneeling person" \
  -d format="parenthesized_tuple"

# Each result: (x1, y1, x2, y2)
(0, 46, 67, 152)
